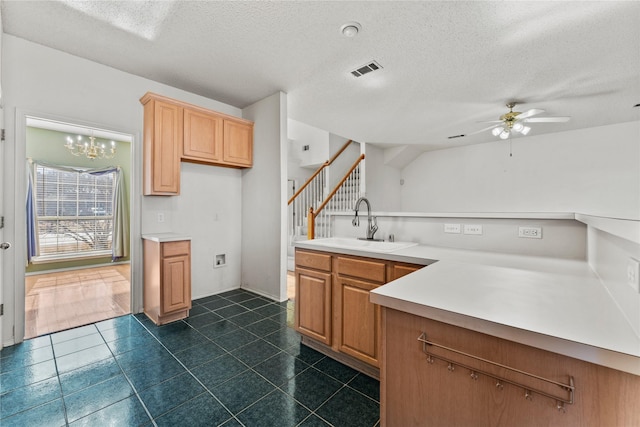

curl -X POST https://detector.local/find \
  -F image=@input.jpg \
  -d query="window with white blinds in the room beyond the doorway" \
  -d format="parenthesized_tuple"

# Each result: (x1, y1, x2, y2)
(34, 164, 116, 259)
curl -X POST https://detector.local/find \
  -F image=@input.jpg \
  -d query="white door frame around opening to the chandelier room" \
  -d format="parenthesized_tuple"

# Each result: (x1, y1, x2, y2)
(9, 108, 142, 344)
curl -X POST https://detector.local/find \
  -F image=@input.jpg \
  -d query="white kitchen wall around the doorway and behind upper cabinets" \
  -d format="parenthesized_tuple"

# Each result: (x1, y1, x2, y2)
(2, 34, 242, 342)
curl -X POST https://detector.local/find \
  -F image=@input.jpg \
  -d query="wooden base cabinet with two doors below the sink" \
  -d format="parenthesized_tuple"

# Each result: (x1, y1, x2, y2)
(295, 249, 423, 377)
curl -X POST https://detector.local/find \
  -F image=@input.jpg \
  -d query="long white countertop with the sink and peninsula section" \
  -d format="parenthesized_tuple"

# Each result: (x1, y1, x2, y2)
(296, 239, 640, 375)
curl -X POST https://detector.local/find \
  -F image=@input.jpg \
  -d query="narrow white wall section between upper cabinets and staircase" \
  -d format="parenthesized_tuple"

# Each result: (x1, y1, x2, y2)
(242, 92, 288, 301)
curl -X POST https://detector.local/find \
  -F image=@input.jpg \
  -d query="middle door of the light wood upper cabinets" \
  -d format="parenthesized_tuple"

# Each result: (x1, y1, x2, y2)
(182, 108, 224, 162)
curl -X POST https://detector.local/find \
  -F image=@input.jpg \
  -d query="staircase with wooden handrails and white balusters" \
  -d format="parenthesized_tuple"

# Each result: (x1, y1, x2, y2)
(289, 140, 364, 247)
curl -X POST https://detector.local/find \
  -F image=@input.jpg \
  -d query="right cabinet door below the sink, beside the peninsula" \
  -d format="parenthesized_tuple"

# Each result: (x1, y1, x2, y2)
(334, 275, 380, 367)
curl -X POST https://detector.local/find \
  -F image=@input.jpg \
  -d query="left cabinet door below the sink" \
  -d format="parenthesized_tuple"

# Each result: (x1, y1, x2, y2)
(295, 268, 331, 345)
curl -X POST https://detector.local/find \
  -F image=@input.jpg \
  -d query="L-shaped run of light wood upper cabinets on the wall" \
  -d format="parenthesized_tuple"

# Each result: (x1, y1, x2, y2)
(140, 93, 253, 196)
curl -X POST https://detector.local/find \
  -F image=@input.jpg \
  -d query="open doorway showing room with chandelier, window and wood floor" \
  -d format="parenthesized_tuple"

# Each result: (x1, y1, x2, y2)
(24, 117, 133, 339)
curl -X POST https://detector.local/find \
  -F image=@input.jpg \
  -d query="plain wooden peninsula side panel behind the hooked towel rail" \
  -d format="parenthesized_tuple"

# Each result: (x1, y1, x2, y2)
(380, 307, 640, 427)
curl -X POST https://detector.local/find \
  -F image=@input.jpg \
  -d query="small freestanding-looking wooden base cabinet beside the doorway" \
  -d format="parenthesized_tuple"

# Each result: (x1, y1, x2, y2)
(143, 239, 191, 325)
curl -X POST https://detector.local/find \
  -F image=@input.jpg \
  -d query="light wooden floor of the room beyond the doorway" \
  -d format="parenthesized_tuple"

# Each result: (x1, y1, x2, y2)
(25, 264, 131, 339)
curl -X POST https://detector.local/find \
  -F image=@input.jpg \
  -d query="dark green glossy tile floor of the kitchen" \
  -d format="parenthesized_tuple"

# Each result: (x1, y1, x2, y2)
(0, 290, 380, 427)
